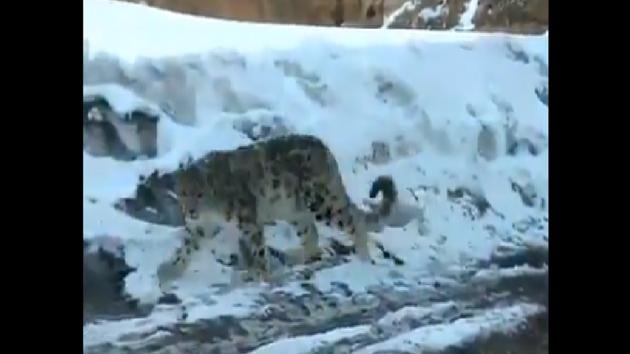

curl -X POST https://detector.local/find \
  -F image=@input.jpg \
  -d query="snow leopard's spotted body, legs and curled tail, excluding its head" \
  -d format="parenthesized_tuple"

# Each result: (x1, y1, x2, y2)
(159, 135, 397, 286)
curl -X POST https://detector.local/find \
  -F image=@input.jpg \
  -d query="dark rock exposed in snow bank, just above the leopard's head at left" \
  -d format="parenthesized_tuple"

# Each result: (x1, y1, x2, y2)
(83, 95, 159, 161)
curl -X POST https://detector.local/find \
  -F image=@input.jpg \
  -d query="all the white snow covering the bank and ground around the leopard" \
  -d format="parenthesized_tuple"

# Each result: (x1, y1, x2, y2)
(83, 0, 549, 353)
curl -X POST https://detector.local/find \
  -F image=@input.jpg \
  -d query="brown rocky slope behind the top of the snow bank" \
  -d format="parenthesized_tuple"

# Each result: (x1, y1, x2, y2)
(117, 0, 549, 34)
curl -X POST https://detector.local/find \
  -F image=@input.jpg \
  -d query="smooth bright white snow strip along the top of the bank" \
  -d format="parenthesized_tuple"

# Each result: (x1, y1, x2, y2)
(83, 0, 544, 61)
